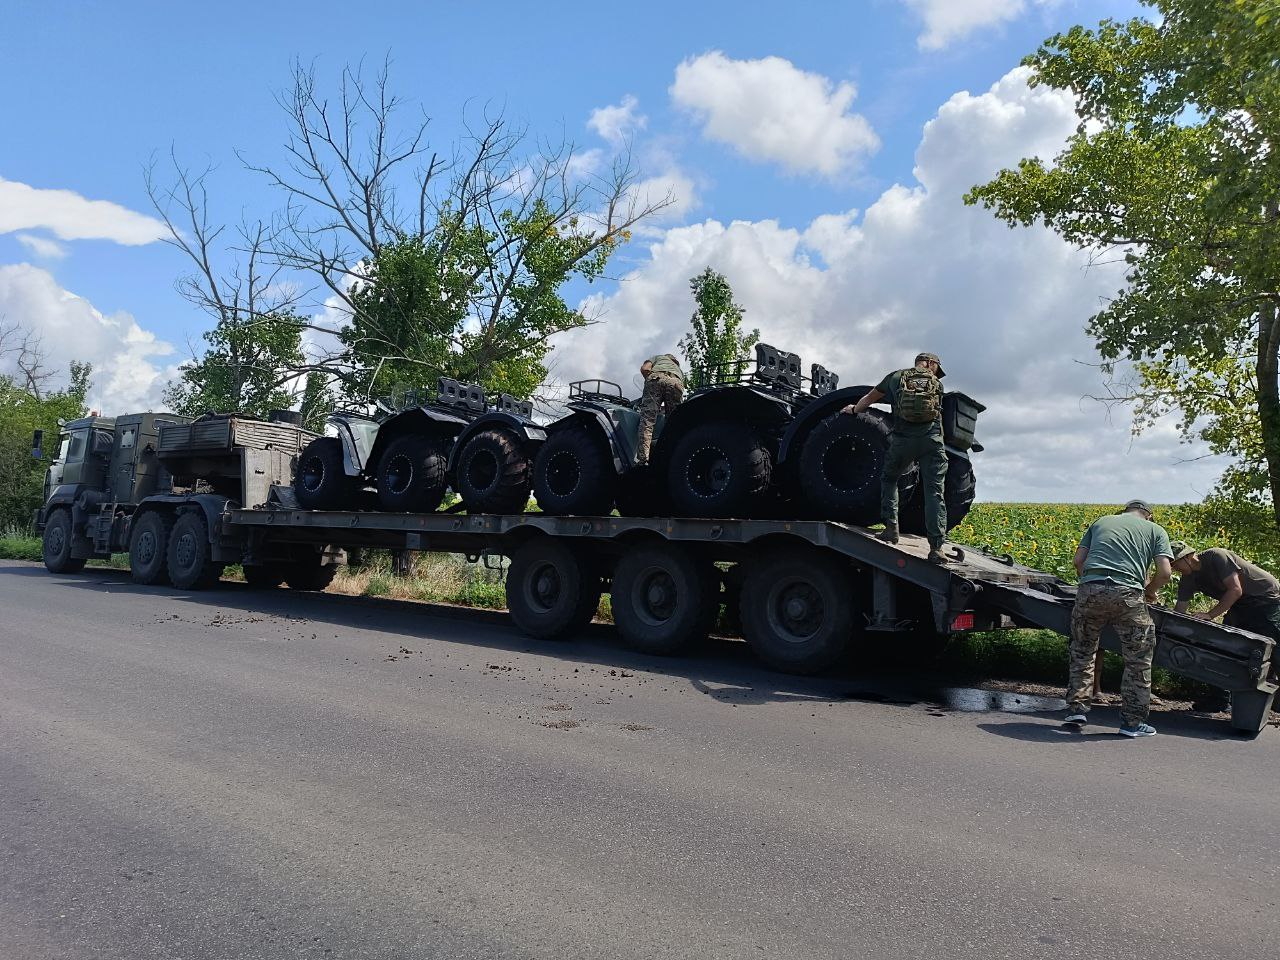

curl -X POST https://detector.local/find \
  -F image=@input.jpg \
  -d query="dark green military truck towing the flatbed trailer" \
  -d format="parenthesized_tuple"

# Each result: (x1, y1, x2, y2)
(33, 411, 343, 590)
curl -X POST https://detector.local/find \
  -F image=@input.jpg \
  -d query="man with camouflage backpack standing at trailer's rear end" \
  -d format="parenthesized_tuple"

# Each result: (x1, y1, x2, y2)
(840, 353, 947, 563)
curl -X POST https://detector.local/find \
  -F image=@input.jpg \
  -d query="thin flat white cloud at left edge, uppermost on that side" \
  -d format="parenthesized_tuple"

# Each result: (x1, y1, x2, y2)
(0, 177, 166, 246)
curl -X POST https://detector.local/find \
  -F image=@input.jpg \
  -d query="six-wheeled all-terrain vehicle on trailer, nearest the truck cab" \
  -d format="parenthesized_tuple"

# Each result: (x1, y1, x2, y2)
(294, 378, 545, 513)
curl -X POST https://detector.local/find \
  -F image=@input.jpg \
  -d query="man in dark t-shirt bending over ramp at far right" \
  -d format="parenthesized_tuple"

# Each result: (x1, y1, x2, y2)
(1171, 541, 1280, 643)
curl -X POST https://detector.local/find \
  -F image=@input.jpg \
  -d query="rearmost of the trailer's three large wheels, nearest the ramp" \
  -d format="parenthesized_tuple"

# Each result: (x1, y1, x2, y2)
(741, 549, 855, 673)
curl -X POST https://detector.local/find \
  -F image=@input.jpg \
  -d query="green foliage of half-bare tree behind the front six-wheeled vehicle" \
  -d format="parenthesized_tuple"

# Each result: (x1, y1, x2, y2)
(339, 201, 614, 399)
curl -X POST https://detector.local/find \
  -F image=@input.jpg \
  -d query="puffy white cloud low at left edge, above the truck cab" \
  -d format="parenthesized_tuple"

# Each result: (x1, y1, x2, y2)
(0, 264, 177, 415)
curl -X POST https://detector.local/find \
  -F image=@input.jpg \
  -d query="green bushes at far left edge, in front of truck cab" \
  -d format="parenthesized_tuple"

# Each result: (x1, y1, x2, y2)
(0, 364, 91, 529)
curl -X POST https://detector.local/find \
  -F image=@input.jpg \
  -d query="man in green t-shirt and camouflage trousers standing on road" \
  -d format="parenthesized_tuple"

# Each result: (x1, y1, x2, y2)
(1065, 500, 1172, 737)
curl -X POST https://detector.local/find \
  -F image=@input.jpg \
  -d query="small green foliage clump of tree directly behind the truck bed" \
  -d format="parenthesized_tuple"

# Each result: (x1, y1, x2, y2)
(164, 312, 307, 419)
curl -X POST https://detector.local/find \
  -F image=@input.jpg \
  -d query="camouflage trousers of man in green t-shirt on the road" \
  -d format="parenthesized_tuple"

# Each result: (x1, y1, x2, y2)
(1066, 582, 1156, 727)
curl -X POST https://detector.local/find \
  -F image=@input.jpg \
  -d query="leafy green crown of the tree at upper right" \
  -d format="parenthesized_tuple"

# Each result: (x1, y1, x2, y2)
(965, 0, 1280, 525)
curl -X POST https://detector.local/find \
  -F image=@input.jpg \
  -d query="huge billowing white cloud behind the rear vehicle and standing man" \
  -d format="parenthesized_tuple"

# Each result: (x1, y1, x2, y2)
(556, 69, 1224, 502)
